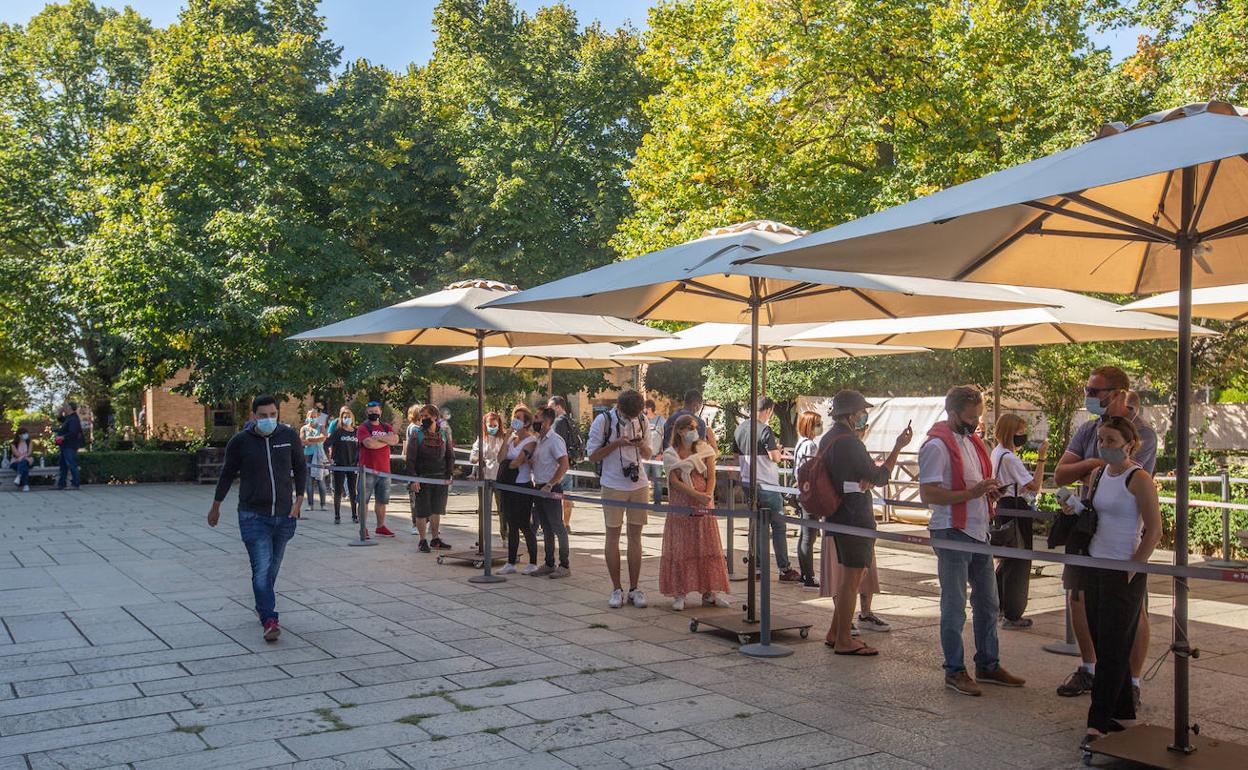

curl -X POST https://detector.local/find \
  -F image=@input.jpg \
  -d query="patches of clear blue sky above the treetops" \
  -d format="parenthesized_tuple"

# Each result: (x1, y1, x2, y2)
(0, 0, 1138, 69)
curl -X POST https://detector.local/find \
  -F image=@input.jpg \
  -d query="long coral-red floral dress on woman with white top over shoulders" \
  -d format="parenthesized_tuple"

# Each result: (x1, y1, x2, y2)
(659, 464, 728, 597)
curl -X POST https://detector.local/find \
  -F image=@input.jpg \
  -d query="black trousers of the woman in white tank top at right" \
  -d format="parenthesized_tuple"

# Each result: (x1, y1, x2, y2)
(1080, 567, 1148, 733)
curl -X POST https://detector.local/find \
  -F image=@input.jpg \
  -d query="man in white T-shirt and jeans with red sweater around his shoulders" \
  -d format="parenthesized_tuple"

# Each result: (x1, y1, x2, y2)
(919, 386, 1025, 695)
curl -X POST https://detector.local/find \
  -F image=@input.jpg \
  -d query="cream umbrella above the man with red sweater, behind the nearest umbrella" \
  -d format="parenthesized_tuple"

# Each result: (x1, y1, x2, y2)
(788, 288, 1214, 424)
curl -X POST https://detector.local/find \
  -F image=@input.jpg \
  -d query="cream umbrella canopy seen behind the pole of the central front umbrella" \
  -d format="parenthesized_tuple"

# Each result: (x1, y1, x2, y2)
(628, 322, 927, 362)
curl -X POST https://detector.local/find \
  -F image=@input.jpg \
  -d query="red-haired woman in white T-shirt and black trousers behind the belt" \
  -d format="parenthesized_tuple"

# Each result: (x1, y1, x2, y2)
(992, 412, 1048, 629)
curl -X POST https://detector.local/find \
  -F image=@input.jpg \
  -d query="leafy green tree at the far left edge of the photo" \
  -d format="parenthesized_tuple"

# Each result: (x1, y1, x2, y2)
(0, 0, 151, 429)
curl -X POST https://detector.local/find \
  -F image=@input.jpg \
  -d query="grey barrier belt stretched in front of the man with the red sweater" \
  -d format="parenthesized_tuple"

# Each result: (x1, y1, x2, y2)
(771, 513, 1248, 583)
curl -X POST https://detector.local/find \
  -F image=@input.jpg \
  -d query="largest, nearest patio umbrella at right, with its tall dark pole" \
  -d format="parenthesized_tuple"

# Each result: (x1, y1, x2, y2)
(743, 101, 1248, 755)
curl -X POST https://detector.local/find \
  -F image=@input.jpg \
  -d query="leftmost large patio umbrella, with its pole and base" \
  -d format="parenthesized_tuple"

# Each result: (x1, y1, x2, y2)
(290, 280, 668, 583)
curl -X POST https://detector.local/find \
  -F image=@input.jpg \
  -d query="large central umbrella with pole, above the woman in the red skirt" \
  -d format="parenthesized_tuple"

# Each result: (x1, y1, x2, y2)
(489, 221, 1041, 656)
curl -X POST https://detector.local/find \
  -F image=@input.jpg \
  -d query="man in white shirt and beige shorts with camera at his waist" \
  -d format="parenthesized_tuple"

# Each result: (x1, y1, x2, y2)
(585, 389, 650, 609)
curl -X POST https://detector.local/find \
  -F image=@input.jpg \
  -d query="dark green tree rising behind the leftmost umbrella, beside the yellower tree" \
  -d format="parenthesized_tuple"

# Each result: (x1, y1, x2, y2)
(424, 0, 650, 286)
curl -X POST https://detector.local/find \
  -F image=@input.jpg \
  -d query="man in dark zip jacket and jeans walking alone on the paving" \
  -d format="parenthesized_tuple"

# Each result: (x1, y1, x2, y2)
(208, 396, 308, 641)
